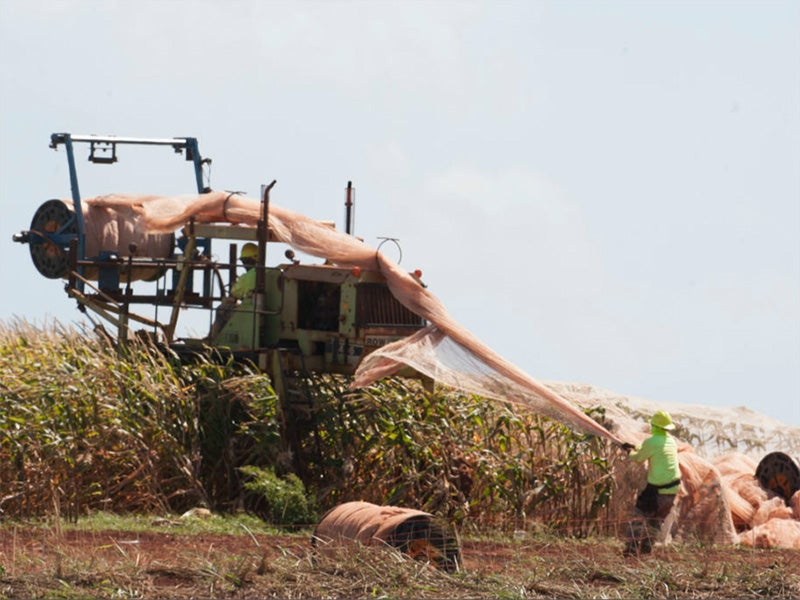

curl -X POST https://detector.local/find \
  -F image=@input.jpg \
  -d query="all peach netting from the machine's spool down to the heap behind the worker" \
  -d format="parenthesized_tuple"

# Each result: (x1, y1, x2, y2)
(65, 192, 800, 548)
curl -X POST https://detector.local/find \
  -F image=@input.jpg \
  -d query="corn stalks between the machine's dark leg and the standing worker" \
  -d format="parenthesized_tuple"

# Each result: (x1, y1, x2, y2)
(296, 376, 613, 535)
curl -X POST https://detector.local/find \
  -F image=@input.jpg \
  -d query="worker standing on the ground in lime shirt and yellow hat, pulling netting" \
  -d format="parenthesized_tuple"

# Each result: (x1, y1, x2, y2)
(623, 410, 681, 556)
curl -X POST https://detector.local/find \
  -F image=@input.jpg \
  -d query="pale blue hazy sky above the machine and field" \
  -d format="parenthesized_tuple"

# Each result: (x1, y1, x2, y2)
(0, 0, 800, 425)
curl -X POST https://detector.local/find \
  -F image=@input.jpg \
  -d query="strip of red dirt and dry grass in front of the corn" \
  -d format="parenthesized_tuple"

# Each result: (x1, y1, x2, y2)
(0, 524, 800, 600)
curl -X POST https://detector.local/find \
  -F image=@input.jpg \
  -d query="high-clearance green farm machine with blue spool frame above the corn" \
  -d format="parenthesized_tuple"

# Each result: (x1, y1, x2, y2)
(14, 133, 426, 446)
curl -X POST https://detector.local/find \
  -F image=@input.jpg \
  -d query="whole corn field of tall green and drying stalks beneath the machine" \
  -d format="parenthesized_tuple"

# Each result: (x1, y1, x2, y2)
(0, 321, 617, 536)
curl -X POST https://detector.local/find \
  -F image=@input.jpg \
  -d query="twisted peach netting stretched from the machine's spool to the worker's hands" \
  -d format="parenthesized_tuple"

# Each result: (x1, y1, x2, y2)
(78, 192, 622, 443)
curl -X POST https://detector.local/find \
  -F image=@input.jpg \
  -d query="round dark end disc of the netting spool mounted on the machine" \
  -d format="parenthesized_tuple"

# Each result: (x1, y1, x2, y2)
(29, 200, 78, 279)
